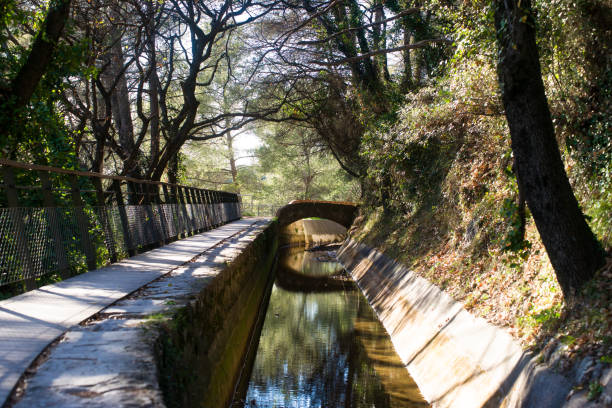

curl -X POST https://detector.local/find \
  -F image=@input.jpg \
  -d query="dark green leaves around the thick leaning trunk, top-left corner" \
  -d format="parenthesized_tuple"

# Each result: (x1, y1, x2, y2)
(0, 2, 90, 168)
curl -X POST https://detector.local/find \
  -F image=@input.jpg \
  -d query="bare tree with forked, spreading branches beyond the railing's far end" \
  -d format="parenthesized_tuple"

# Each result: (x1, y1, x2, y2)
(147, 0, 288, 180)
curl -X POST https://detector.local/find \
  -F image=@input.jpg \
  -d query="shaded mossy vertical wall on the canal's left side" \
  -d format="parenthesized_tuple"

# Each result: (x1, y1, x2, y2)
(157, 223, 278, 408)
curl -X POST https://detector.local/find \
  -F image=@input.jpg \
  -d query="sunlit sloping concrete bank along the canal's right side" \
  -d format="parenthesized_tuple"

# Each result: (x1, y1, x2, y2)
(338, 239, 571, 408)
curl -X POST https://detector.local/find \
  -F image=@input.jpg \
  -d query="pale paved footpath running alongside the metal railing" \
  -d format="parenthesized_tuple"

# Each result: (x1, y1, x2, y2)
(0, 219, 256, 406)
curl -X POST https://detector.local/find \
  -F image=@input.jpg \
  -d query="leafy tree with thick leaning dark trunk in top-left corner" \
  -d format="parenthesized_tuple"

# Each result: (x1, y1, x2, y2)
(0, 0, 83, 166)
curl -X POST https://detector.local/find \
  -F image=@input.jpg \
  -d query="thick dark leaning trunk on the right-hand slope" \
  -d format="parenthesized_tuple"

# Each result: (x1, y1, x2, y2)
(494, 0, 605, 299)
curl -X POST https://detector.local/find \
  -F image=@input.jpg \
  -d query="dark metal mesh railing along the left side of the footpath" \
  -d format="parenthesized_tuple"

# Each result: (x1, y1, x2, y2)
(0, 159, 241, 289)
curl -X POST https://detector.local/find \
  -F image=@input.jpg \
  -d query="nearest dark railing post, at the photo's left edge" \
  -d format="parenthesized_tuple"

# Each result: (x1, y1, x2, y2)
(2, 166, 36, 290)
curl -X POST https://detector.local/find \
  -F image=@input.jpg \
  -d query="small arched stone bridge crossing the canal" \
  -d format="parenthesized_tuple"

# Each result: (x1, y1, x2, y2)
(276, 200, 358, 229)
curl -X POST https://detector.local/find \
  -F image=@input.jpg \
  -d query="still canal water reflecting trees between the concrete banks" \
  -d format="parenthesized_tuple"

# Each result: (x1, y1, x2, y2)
(231, 248, 428, 408)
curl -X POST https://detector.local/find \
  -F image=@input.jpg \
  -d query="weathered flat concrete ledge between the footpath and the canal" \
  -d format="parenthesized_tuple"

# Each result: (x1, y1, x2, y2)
(10, 220, 270, 408)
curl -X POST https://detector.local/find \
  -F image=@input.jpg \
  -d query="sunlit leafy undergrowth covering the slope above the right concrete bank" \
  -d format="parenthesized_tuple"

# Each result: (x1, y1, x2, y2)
(352, 51, 612, 368)
